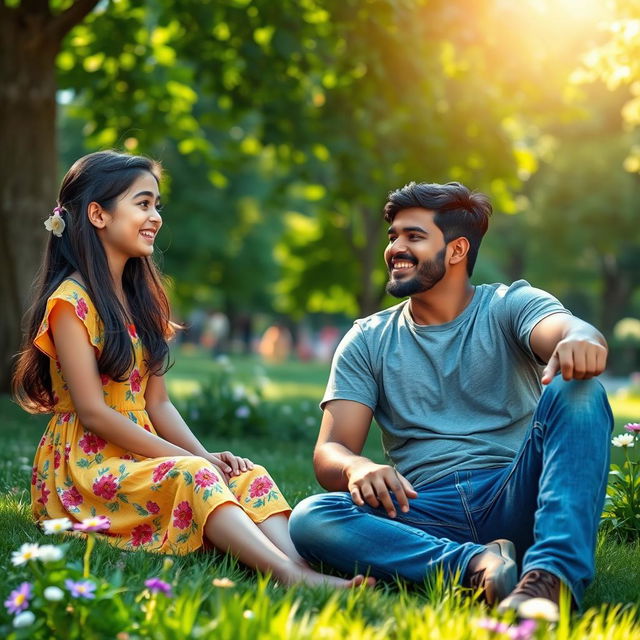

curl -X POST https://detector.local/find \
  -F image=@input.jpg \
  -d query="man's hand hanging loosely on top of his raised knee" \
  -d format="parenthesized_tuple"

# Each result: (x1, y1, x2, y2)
(541, 336, 607, 384)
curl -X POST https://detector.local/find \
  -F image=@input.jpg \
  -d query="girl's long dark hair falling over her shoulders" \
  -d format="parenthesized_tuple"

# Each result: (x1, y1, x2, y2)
(13, 151, 172, 413)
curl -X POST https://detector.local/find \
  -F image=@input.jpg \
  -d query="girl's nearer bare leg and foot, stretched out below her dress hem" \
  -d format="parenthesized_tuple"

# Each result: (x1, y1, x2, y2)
(204, 503, 374, 588)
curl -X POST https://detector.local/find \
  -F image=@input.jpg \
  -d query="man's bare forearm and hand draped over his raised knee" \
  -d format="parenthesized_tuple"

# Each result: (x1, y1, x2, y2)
(529, 313, 609, 384)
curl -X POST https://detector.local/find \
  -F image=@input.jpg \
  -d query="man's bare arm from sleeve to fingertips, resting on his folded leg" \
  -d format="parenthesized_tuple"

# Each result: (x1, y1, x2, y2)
(313, 400, 418, 518)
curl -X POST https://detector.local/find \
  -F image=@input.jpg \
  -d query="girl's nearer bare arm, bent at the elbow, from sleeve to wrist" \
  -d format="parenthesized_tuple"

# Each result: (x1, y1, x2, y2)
(49, 304, 193, 458)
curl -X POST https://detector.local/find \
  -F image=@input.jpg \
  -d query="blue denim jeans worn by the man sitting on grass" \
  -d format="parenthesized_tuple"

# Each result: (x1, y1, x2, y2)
(289, 376, 613, 604)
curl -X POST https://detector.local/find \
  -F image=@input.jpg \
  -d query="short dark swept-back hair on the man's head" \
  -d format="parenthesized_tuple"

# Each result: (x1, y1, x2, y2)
(384, 182, 493, 276)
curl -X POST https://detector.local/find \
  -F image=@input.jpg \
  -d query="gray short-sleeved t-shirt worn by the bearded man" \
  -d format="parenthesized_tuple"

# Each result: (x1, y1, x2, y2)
(320, 280, 569, 485)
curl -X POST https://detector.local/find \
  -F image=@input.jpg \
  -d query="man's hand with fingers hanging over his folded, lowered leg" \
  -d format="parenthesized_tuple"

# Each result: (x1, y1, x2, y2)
(347, 458, 418, 518)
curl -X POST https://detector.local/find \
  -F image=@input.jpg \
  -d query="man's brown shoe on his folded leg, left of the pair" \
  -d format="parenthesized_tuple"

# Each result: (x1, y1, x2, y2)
(462, 539, 518, 606)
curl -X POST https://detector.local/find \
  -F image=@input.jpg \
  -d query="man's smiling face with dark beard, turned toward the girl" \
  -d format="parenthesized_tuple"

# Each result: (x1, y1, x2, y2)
(384, 207, 447, 298)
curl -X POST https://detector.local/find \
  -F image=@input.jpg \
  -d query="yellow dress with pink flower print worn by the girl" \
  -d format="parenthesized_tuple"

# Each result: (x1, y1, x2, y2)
(31, 279, 290, 554)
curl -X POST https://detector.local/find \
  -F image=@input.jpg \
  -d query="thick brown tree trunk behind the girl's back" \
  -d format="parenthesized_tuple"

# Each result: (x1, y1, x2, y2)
(0, 0, 97, 392)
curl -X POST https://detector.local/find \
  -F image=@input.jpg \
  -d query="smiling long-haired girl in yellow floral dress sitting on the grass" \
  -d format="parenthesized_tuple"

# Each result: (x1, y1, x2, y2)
(14, 151, 372, 587)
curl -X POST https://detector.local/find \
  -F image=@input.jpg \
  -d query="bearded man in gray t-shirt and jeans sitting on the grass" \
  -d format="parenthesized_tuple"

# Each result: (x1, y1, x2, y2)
(290, 182, 612, 610)
